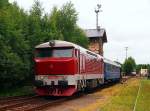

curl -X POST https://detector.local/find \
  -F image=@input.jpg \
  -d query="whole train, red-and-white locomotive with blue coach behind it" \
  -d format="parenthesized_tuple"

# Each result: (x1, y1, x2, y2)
(34, 40, 121, 96)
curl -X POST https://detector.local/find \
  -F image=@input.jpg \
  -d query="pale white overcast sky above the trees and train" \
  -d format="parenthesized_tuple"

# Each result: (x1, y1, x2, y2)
(9, 0, 150, 64)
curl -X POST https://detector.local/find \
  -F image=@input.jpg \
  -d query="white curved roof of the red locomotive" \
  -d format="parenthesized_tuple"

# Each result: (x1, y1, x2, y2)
(35, 40, 103, 58)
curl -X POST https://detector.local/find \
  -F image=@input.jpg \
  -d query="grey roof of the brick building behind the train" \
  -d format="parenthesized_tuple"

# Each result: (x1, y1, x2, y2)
(84, 29, 107, 42)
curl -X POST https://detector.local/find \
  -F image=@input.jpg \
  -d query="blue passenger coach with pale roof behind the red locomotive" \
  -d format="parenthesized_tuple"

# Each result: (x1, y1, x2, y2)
(104, 58, 121, 82)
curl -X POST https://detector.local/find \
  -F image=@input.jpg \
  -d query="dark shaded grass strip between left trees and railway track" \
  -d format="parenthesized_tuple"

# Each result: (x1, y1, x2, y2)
(0, 86, 34, 97)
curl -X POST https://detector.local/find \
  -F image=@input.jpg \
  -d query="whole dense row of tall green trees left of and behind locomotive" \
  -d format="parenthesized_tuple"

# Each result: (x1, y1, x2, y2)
(0, 0, 88, 88)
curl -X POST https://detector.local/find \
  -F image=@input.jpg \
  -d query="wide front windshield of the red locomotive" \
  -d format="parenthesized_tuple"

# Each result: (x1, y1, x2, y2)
(35, 48, 73, 58)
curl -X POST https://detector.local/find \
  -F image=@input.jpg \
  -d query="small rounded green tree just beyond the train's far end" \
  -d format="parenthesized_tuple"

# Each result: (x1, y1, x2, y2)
(122, 57, 136, 75)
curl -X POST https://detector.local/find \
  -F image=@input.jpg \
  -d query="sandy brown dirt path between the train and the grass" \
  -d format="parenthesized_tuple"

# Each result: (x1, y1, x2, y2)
(45, 78, 138, 111)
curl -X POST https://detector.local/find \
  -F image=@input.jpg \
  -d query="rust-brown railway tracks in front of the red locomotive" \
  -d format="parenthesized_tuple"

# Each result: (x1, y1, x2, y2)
(0, 95, 82, 111)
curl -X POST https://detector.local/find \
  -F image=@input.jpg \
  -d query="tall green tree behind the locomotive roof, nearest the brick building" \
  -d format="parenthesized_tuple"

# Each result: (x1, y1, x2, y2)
(50, 2, 88, 48)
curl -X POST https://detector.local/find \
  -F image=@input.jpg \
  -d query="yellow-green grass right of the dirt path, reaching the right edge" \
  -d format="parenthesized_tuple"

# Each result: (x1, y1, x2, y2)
(100, 79, 150, 111)
